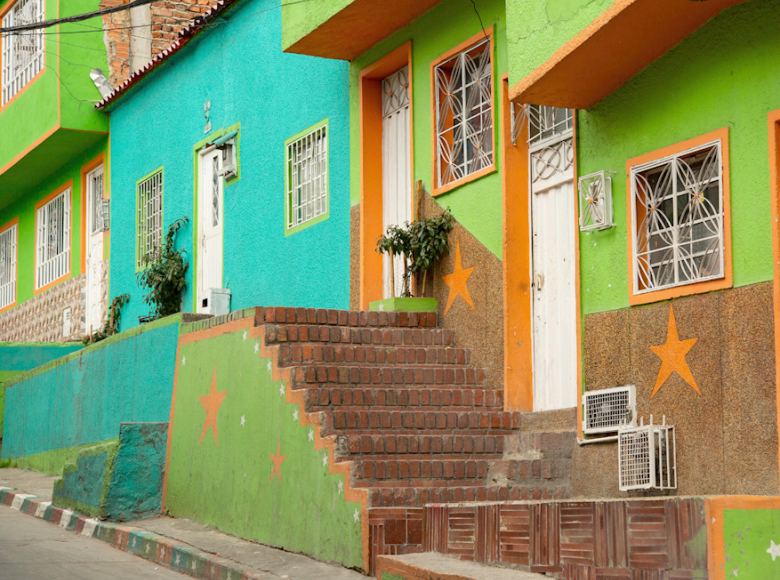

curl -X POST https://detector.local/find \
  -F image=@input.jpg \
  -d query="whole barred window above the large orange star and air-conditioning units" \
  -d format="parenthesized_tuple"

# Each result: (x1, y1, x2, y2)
(631, 141, 724, 294)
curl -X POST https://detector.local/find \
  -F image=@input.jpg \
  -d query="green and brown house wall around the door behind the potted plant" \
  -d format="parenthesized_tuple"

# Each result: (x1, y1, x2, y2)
(344, 0, 508, 389)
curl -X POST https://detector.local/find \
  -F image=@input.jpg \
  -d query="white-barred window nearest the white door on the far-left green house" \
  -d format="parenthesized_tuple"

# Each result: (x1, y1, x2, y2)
(35, 189, 71, 290)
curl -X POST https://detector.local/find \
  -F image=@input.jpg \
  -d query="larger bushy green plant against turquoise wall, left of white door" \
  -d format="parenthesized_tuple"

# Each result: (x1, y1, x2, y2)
(137, 217, 189, 320)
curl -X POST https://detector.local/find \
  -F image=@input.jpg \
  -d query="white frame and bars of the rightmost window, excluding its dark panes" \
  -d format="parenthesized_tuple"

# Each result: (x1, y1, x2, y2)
(630, 139, 726, 295)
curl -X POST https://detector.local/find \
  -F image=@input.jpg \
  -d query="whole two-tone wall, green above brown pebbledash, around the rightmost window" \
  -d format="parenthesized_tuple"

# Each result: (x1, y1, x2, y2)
(573, 0, 780, 498)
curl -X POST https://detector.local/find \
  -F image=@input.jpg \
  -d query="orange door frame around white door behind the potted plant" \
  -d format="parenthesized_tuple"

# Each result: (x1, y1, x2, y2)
(359, 42, 414, 310)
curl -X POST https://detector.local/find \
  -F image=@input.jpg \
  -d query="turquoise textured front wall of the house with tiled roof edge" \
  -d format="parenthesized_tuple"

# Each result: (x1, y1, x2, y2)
(110, 0, 349, 328)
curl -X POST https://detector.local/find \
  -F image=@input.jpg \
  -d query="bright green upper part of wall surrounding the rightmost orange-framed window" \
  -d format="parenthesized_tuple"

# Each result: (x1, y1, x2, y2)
(577, 0, 780, 314)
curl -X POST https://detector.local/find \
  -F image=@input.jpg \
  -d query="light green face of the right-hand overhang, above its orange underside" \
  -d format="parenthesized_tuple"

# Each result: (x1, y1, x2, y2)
(506, 0, 614, 87)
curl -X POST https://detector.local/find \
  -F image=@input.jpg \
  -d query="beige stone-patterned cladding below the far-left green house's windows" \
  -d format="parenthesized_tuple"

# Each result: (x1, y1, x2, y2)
(0, 274, 86, 342)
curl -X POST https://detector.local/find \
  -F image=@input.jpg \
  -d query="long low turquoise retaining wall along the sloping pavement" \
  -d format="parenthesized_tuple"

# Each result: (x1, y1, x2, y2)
(2, 315, 181, 474)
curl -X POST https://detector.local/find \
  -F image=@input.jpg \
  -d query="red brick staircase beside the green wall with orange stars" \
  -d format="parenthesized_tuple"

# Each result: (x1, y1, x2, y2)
(256, 308, 573, 570)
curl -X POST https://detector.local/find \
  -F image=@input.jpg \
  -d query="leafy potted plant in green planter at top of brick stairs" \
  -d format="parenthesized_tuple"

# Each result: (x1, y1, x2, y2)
(369, 211, 454, 312)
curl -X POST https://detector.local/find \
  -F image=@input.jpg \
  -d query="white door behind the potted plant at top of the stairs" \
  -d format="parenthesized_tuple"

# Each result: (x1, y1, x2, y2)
(382, 67, 412, 298)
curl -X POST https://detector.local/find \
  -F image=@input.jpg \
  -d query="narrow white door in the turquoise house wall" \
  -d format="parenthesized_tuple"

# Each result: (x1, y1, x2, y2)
(196, 147, 224, 314)
